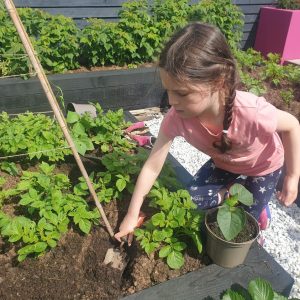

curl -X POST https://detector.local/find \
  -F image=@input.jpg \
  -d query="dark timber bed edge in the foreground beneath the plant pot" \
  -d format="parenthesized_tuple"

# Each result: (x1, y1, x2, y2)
(123, 243, 294, 300)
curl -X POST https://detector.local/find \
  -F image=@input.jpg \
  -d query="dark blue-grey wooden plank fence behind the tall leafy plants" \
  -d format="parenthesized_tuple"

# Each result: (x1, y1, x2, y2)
(14, 0, 274, 48)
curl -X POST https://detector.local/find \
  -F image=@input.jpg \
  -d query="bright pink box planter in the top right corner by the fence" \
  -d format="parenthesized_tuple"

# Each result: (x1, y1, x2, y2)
(254, 7, 300, 63)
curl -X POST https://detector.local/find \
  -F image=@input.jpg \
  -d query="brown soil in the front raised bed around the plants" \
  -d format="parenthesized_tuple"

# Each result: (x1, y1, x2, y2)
(0, 162, 211, 300)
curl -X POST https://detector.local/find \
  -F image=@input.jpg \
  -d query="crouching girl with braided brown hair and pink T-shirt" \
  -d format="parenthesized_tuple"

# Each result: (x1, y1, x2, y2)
(115, 23, 300, 244)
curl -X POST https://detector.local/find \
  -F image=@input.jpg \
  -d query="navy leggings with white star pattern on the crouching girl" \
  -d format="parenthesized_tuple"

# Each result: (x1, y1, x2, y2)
(187, 159, 282, 219)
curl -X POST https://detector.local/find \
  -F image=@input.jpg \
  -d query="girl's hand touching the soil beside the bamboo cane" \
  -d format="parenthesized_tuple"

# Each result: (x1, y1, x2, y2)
(115, 212, 146, 246)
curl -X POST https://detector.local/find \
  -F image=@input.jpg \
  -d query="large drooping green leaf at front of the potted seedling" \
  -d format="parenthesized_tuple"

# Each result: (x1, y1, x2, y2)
(217, 206, 246, 241)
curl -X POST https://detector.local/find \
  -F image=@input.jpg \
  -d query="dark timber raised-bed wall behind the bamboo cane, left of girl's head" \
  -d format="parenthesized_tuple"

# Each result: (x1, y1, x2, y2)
(0, 68, 164, 113)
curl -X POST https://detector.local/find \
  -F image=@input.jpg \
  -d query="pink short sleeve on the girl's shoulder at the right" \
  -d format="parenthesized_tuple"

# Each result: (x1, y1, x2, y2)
(256, 97, 277, 135)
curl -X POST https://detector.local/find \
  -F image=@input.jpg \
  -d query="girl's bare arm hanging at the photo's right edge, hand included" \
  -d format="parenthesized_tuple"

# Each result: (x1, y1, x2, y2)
(277, 109, 300, 206)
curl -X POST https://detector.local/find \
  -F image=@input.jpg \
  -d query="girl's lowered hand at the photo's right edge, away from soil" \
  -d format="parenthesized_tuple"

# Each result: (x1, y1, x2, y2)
(277, 175, 299, 206)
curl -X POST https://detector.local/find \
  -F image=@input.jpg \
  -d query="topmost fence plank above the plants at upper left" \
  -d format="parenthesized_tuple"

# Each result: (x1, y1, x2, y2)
(14, 0, 126, 7)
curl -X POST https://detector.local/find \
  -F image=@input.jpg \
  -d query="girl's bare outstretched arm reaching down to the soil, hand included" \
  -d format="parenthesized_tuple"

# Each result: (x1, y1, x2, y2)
(115, 130, 172, 244)
